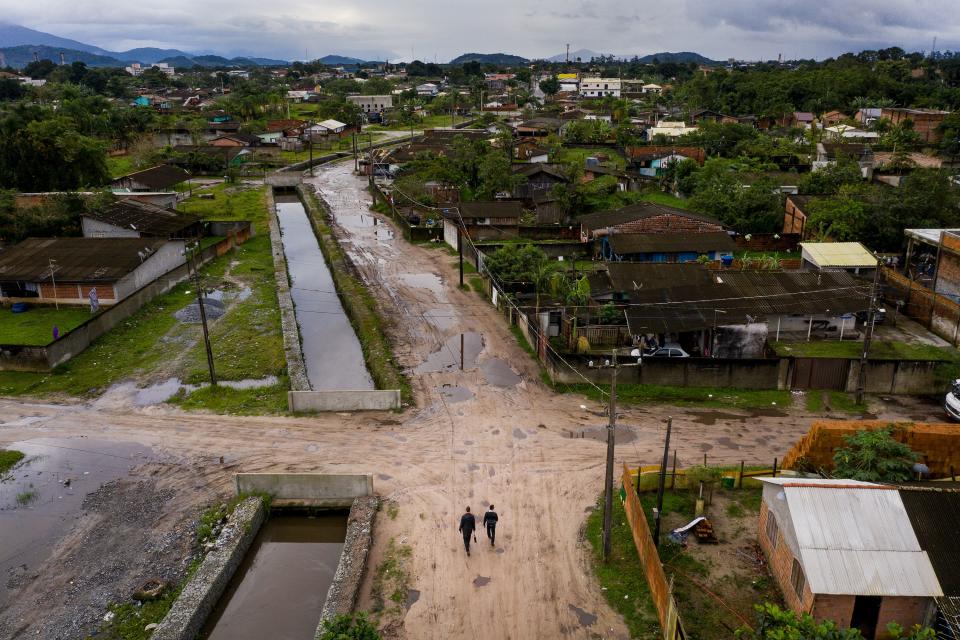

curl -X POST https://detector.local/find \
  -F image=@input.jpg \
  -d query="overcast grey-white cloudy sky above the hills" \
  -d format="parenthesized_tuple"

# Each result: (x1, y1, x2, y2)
(7, 0, 960, 62)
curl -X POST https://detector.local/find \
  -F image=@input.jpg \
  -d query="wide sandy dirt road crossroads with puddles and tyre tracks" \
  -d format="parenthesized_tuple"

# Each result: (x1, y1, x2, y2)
(0, 163, 937, 640)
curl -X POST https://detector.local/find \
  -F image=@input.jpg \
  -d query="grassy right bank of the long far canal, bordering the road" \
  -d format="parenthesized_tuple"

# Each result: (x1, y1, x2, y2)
(291, 184, 413, 411)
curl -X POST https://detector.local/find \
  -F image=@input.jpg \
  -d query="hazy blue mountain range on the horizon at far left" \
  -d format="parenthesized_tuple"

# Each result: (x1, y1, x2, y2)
(0, 23, 289, 67)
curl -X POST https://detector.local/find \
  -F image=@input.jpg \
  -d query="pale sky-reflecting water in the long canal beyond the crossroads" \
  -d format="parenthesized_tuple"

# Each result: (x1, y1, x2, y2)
(276, 195, 374, 391)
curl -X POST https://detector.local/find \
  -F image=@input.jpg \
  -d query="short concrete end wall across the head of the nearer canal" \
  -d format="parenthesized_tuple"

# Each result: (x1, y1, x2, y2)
(234, 473, 373, 506)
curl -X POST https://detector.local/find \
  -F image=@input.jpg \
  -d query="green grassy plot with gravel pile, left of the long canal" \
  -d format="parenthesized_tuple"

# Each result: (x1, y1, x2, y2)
(0, 185, 287, 413)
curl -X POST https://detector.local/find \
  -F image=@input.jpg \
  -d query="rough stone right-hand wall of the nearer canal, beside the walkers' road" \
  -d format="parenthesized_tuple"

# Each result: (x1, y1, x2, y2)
(316, 495, 380, 640)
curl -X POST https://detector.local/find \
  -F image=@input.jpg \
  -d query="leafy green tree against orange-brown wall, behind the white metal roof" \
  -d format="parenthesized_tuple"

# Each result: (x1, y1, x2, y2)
(833, 427, 917, 482)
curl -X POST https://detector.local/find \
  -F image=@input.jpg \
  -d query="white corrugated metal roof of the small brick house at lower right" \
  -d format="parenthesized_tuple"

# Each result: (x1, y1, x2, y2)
(765, 488, 943, 597)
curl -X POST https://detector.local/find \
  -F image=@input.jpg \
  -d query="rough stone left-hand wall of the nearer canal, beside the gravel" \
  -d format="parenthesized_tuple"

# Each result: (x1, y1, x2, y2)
(150, 497, 267, 640)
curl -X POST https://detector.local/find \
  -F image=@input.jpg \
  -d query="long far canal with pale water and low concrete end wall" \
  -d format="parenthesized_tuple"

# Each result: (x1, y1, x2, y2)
(274, 192, 399, 411)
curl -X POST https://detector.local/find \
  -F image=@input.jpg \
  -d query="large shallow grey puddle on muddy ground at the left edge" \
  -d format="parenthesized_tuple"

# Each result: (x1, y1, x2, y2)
(0, 438, 155, 609)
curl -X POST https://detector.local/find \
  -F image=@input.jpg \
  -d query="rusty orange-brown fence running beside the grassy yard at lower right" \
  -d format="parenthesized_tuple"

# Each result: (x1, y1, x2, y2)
(621, 465, 685, 640)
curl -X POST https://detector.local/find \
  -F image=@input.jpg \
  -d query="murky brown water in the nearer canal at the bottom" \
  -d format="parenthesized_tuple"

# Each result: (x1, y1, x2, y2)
(201, 511, 348, 640)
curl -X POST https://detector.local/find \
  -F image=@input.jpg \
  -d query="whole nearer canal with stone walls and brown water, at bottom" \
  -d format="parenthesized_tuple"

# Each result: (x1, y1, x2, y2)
(151, 474, 379, 640)
